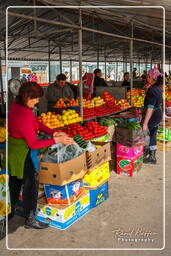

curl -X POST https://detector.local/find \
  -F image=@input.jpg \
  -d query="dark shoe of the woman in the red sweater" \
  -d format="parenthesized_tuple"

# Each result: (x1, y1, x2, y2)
(24, 213, 49, 229)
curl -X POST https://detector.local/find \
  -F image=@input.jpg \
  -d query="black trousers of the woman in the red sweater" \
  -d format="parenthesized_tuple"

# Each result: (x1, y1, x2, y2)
(9, 152, 39, 217)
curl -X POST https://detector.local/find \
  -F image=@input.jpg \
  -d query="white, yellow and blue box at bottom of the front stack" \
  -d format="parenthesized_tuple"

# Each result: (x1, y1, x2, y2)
(36, 191, 90, 230)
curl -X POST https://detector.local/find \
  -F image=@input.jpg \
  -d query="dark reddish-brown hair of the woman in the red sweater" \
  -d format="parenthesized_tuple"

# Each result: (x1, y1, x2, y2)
(16, 82, 44, 105)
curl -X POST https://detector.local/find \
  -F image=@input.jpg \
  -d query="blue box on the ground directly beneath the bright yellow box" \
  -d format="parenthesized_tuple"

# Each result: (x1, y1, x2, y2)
(85, 182, 108, 208)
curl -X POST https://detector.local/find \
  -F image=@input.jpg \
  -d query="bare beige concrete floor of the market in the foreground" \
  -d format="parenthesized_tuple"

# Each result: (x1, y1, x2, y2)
(0, 152, 171, 256)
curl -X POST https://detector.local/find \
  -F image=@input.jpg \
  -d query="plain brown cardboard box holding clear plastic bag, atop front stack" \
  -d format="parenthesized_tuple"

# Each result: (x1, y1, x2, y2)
(39, 153, 87, 186)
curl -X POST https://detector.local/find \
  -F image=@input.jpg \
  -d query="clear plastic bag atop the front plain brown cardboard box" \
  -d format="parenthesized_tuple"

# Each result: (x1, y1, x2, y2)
(41, 143, 84, 163)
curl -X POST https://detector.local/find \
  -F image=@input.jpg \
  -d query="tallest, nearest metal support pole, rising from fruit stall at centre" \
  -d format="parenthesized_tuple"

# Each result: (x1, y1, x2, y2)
(78, 9, 83, 118)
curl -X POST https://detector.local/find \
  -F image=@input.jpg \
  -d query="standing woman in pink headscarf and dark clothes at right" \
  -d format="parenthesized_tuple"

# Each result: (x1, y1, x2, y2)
(143, 68, 163, 164)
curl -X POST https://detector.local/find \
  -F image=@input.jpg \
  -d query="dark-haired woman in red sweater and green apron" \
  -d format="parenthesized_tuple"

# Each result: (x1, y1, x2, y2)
(8, 82, 73, 229)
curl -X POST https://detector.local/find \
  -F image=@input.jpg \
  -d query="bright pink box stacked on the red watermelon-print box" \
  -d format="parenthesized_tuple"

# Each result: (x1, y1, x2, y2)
(116, 143, 144, 158)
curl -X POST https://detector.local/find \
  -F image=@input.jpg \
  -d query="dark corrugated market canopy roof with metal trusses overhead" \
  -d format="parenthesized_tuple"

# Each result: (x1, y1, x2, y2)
(0, 0, 171, 62)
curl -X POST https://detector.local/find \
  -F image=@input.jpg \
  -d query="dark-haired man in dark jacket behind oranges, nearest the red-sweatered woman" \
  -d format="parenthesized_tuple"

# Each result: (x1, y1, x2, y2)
(46, 74, 74, 111)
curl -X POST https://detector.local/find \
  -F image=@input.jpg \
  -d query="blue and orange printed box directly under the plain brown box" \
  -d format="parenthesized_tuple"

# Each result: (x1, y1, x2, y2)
(44, 180, 84, 205)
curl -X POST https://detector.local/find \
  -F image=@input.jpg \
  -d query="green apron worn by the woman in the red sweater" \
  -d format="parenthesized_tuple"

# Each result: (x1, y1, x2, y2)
(8, 136, 29, 179)
